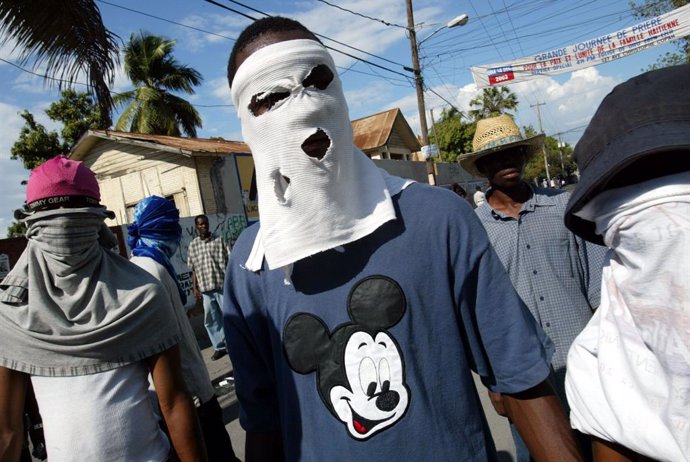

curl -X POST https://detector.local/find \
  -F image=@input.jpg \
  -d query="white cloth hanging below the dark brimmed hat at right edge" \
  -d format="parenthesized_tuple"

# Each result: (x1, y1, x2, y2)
(566, 172, 690, 462)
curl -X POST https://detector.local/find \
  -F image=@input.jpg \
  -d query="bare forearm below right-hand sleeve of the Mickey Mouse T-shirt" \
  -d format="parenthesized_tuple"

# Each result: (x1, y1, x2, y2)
(492, 381, 584, 462)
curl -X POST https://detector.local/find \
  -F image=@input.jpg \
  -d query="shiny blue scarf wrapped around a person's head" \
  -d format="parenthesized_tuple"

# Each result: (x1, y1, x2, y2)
(127, 196, 187, 305)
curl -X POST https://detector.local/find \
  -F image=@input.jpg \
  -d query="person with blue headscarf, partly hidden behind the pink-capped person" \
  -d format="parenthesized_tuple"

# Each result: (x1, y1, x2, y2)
(127, 196, 239, 461)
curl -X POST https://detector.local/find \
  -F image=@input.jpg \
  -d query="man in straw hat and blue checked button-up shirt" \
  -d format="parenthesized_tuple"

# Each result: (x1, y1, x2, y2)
(459, 114, 606, 462)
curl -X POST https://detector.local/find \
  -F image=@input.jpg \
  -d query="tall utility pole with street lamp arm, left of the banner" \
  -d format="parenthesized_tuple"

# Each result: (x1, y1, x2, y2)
(406, 0, 469, 185)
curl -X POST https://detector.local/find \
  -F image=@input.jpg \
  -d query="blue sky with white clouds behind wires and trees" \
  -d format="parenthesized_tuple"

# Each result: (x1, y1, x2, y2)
(0, 0, 674, 237)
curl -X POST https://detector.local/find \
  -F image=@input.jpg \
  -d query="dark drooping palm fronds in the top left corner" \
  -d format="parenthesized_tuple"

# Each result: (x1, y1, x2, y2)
(0, 0, 118, 128)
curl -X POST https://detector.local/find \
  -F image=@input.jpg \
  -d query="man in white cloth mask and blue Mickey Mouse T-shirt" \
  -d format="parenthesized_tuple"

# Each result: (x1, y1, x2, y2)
(224, 17, 579, 461)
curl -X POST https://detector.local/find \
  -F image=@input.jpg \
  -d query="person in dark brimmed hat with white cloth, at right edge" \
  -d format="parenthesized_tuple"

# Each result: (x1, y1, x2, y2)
(565, 64, 690, 462)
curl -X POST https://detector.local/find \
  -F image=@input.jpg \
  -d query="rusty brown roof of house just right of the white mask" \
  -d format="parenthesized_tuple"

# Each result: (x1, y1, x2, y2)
(352, 108, 421, 152)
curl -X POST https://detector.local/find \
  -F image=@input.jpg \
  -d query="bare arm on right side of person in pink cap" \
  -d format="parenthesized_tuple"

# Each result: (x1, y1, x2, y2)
(148, 345, 207, 462)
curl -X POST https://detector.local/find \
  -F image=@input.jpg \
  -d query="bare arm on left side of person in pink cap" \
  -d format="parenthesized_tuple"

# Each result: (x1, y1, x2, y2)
(0, 367, 29, 461)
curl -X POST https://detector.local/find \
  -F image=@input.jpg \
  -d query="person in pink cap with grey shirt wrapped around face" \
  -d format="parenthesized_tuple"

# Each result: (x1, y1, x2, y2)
(0, 156, 206, 462)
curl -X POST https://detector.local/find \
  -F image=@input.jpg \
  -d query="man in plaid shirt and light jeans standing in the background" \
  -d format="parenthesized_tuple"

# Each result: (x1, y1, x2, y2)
(187, 215, 229, 361)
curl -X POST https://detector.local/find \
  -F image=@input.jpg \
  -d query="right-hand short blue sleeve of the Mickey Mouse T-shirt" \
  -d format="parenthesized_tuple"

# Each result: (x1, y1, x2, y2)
(454, 216, 553, 393)
